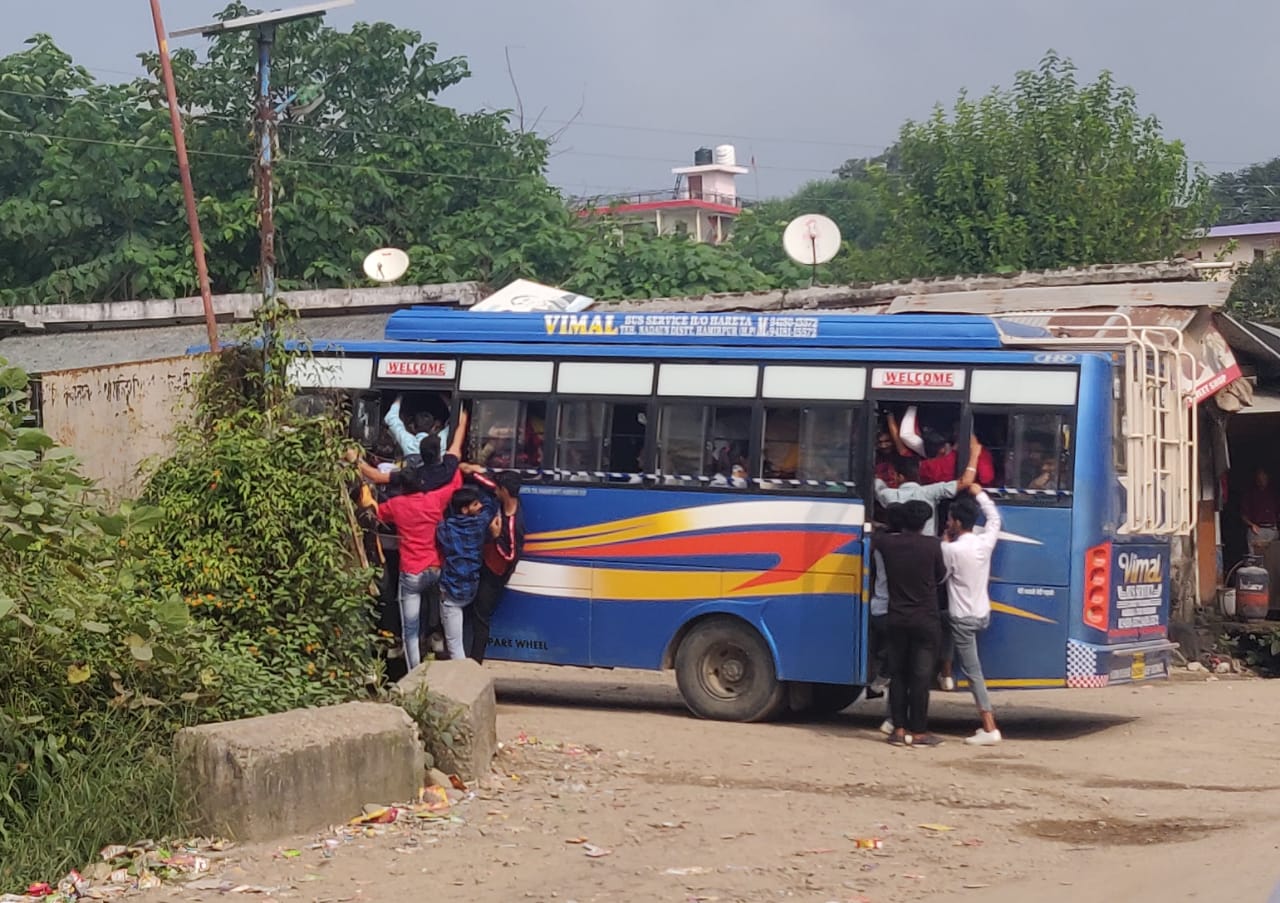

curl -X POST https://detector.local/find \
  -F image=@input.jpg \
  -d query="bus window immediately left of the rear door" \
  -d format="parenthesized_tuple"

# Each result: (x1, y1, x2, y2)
(760, 406, 859, 492)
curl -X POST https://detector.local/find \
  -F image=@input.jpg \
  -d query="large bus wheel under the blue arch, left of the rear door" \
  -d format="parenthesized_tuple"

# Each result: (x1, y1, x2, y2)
(676, 617, 787, 721)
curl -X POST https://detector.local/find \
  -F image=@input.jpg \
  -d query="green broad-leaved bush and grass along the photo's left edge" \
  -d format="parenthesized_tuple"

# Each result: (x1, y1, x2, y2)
(0, 365, 204, 888)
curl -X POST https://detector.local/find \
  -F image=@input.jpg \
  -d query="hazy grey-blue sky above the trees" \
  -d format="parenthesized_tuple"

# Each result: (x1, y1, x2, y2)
(0, 0, 1280, 197)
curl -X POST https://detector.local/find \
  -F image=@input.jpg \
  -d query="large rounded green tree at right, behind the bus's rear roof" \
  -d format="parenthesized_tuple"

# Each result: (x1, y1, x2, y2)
(873, 53, 1208, 275)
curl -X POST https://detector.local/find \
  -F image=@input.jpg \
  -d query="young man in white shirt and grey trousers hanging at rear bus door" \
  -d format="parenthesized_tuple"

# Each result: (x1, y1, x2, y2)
(942, 483, 1002, 747)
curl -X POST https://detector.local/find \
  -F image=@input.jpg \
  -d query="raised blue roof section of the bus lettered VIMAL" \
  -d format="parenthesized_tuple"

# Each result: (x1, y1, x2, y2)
(385, 307, 1047, 350)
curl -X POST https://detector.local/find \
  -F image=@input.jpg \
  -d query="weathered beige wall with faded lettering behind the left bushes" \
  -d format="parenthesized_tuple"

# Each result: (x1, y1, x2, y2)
(40, 357, 204, 498)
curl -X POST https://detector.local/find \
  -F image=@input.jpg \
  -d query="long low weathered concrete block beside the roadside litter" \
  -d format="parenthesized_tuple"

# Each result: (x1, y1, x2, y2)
(174, 702, 425, 840)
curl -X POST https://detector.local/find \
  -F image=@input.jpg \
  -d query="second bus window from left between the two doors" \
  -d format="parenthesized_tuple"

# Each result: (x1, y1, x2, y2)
(556, 401, 645, 483)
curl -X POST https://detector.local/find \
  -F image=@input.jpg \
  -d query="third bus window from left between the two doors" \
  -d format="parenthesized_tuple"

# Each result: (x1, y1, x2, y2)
(658, 405, 751, 488)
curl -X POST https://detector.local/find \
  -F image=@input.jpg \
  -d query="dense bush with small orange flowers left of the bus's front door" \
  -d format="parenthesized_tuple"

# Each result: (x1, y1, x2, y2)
(142, 363, 381, 719)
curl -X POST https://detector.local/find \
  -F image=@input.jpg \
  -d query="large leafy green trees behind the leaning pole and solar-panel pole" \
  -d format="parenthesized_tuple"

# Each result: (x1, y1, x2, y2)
(0, 3, 579, 304)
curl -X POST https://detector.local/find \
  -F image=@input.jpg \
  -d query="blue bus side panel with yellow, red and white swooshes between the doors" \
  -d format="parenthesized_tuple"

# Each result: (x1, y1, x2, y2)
(490, 485, 864, 683)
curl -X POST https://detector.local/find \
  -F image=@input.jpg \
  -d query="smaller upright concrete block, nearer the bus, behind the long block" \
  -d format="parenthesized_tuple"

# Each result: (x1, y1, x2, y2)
(398, 658, 498, 781)
